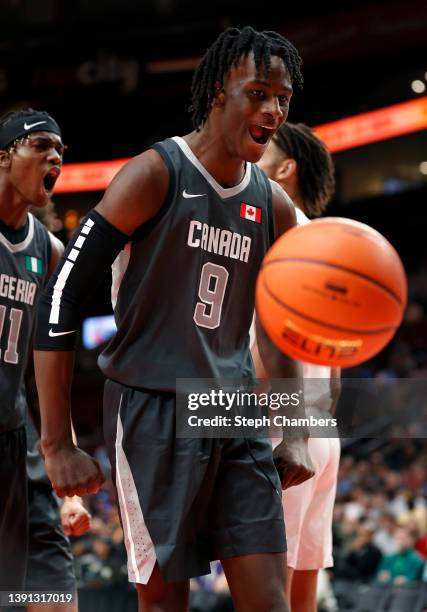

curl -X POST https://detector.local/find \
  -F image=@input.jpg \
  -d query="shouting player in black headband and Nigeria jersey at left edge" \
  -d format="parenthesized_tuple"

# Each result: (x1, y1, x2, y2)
(0, 111, 63, 591)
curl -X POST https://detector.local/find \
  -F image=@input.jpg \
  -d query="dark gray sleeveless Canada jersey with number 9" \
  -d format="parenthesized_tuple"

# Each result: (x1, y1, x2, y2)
(99, 137, 273, 390)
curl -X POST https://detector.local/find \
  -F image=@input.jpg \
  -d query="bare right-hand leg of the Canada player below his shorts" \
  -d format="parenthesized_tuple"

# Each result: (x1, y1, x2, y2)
(221, 553, 288, 612)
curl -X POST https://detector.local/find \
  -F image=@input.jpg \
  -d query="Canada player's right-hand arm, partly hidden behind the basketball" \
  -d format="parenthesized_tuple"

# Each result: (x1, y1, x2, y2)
(253, 181, 314, 489)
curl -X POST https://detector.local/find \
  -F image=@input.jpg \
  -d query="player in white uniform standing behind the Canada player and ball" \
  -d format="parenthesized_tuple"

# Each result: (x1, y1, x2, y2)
(254, 123, 340, 612)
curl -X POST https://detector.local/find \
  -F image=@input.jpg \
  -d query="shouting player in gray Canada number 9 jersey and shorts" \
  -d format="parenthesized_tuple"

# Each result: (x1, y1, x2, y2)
(35, 27, 312, 612)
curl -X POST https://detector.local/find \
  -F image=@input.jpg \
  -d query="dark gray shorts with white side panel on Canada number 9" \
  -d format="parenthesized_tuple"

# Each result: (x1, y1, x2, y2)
(104, 380, 286, 584)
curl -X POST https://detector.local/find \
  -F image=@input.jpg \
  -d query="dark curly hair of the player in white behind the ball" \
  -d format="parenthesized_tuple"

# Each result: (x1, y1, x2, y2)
(273, 123, 335, 218)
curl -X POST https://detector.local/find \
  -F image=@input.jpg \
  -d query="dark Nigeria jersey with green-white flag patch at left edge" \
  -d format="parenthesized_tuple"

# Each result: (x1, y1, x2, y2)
(0, 214, 51, 432)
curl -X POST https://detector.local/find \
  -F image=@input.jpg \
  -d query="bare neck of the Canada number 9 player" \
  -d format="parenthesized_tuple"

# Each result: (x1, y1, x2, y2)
(183, 127, 246, 188)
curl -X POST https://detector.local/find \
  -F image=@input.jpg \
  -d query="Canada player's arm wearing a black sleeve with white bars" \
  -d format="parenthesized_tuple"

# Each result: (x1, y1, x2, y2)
(34, 150, 169, 497)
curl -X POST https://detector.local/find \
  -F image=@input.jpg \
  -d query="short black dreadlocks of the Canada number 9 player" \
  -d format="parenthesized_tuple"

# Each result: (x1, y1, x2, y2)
(189, 26, 303, 130)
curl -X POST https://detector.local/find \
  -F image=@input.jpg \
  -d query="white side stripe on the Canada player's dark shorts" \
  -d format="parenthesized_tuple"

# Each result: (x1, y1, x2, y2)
(116, 396, 156, 584)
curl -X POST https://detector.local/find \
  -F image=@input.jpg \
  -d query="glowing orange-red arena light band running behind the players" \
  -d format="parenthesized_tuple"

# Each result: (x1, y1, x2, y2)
(55, 96, 427, 193)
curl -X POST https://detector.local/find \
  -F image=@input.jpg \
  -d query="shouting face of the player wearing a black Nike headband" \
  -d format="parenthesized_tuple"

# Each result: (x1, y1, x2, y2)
(9, 132, 64, 207)
